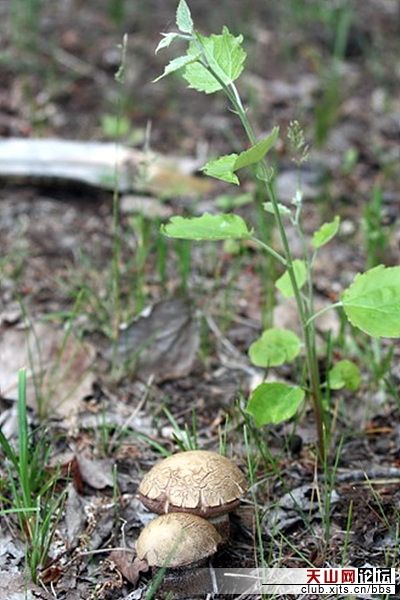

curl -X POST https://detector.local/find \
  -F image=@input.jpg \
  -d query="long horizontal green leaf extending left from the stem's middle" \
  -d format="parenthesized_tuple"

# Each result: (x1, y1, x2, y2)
(161, 213, 251, 240)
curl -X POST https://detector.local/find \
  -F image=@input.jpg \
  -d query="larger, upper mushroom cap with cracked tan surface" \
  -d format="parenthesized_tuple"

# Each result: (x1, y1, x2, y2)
(139, 450, 247, 518)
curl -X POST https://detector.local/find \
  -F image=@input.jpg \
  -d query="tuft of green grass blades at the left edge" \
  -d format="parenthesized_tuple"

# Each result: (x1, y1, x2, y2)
(0, 369, 64, 583)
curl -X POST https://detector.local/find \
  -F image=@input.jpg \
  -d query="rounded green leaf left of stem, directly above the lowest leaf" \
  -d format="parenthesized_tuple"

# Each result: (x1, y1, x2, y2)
(249, 328, 301, 368)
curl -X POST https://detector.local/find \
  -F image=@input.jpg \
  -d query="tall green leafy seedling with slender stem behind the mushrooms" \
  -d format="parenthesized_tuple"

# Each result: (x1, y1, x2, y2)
(155, 0, 400, 460)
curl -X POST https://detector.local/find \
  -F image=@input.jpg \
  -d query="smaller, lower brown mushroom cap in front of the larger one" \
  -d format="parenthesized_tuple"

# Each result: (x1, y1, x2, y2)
(136, 513, 221, 567)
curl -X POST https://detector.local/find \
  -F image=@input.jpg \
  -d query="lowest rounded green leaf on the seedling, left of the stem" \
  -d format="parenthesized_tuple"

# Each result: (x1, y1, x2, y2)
(247, 383, 305, 427)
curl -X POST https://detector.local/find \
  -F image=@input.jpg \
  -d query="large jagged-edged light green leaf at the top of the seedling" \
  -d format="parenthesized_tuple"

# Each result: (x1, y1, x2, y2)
(183, 27, 246, 94)
